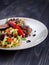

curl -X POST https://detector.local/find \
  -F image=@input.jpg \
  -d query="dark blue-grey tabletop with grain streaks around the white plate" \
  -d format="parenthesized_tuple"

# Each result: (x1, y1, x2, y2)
(0, 0, 49, 65)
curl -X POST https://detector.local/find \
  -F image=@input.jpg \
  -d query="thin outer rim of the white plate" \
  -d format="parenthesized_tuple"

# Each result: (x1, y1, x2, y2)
(0, 17, 48, 50)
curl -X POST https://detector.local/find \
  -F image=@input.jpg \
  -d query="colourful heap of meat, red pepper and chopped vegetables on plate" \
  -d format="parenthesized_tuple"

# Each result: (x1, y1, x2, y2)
(0, 18, 32, 48)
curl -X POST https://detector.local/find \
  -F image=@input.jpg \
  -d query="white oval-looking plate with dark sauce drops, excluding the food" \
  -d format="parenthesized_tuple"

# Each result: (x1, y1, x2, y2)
(0, 17, 48, 50)
